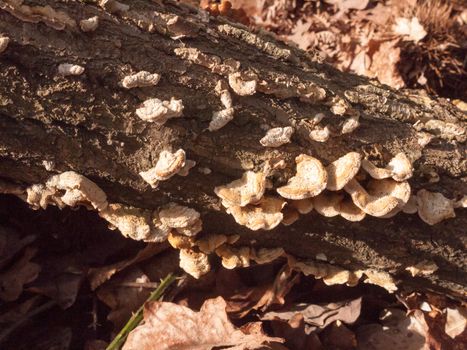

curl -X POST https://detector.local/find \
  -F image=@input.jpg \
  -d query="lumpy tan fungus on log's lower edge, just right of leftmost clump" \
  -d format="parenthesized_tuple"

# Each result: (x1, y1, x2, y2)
(99, 203, 170, 242)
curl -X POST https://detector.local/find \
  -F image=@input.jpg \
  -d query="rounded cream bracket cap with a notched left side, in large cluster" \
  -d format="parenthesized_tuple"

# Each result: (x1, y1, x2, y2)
(277, 154, 328, 200)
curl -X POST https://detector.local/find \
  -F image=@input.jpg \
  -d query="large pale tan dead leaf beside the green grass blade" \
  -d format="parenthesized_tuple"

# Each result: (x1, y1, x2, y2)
(123, 297, 282, 350)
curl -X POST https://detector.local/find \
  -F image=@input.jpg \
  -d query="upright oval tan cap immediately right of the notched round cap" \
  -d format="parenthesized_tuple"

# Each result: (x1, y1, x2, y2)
(326, 152, 362, 191)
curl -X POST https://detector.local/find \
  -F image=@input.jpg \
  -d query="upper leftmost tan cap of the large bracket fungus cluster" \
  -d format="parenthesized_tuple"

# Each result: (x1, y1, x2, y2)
(214, 171, 266, 208)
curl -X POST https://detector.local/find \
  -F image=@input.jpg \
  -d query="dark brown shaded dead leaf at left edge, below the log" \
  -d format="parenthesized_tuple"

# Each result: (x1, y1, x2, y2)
(0, 247, 41, 301)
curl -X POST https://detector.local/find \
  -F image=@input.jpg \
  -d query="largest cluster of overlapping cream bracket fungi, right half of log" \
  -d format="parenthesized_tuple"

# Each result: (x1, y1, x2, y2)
(215, 152, 465, 230)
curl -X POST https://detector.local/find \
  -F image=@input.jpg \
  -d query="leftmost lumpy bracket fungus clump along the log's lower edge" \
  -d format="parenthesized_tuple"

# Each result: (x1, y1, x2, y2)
(26, 171, 108, 210)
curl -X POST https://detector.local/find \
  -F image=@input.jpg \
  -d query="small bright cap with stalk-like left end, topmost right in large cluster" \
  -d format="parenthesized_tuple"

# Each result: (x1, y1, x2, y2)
(362, 152, 413, 181)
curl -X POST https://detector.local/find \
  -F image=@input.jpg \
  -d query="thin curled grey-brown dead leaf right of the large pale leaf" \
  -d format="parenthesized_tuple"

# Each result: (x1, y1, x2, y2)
(261, 298, 362, 333)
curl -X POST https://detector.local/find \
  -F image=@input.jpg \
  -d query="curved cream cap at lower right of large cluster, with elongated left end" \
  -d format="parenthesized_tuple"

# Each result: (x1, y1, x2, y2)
(344, 179, 399, 217)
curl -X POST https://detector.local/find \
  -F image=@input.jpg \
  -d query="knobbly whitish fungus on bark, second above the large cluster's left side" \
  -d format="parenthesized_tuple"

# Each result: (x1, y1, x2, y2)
(136, 97, 184, 125)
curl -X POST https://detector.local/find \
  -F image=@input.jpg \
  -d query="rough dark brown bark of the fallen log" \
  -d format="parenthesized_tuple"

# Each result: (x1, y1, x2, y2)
(0, 0, 467, 298)
